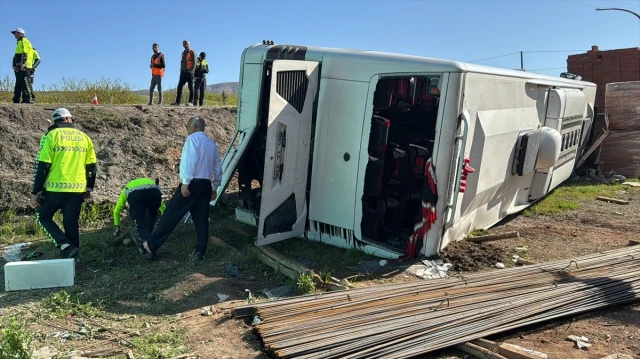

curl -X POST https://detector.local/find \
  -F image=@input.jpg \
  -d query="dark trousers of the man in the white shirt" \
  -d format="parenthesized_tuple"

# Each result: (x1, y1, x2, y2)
(148, 179, 212, 254)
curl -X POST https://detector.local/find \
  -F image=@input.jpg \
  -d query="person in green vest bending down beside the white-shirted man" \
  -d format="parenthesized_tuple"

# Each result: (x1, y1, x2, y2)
(113, 178, 166, 253)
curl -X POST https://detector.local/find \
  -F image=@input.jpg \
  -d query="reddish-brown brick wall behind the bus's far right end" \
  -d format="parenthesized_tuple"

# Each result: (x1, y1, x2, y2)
(567, 46, 640, 113)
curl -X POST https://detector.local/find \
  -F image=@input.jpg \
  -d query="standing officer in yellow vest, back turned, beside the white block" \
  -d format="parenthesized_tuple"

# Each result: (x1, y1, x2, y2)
(31, 108, 97, 258)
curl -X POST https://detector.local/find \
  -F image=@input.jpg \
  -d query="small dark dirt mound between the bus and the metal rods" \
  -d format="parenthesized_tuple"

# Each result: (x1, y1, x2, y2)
(442, 241, 508, 272)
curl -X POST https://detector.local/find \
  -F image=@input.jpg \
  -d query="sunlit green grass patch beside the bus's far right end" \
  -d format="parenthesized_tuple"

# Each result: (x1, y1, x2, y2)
(524, 179, 640, 216)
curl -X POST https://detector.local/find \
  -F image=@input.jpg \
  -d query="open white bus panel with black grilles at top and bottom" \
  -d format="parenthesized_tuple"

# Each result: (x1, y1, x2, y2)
(256, 60, 319, 245)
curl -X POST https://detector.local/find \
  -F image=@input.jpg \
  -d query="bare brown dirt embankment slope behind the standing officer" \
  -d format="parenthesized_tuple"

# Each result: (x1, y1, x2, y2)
(0, 105, 236, 211)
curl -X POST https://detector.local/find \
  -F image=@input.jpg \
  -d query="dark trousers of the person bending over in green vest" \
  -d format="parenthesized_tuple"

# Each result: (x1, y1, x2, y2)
(127, 188, 162, 242)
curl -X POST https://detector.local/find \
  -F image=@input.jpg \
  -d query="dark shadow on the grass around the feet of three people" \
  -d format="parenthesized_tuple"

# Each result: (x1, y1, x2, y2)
(0, 202, 380, 316)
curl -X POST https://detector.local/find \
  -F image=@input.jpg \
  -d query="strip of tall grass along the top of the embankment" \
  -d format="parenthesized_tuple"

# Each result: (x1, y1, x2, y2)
(0, 72, 238, 106)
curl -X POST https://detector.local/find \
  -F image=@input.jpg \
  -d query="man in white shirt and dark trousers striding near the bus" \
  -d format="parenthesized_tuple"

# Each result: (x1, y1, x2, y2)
(140, 116, 222, 260)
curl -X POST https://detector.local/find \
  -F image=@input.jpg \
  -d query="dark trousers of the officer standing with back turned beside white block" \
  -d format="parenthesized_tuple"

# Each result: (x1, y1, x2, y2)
(36, 191, 84, 248)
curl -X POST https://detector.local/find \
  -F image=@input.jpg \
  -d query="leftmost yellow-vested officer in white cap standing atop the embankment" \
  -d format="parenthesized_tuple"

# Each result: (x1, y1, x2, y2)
(11, 28, 34, 103)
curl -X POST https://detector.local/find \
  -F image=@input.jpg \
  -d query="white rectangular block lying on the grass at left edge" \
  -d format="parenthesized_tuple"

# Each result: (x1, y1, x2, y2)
(4, 258, 76, 292)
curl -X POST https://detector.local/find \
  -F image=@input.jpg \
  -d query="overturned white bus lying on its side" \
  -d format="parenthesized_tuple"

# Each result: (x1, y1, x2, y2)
(212, 42, 596, 258)
